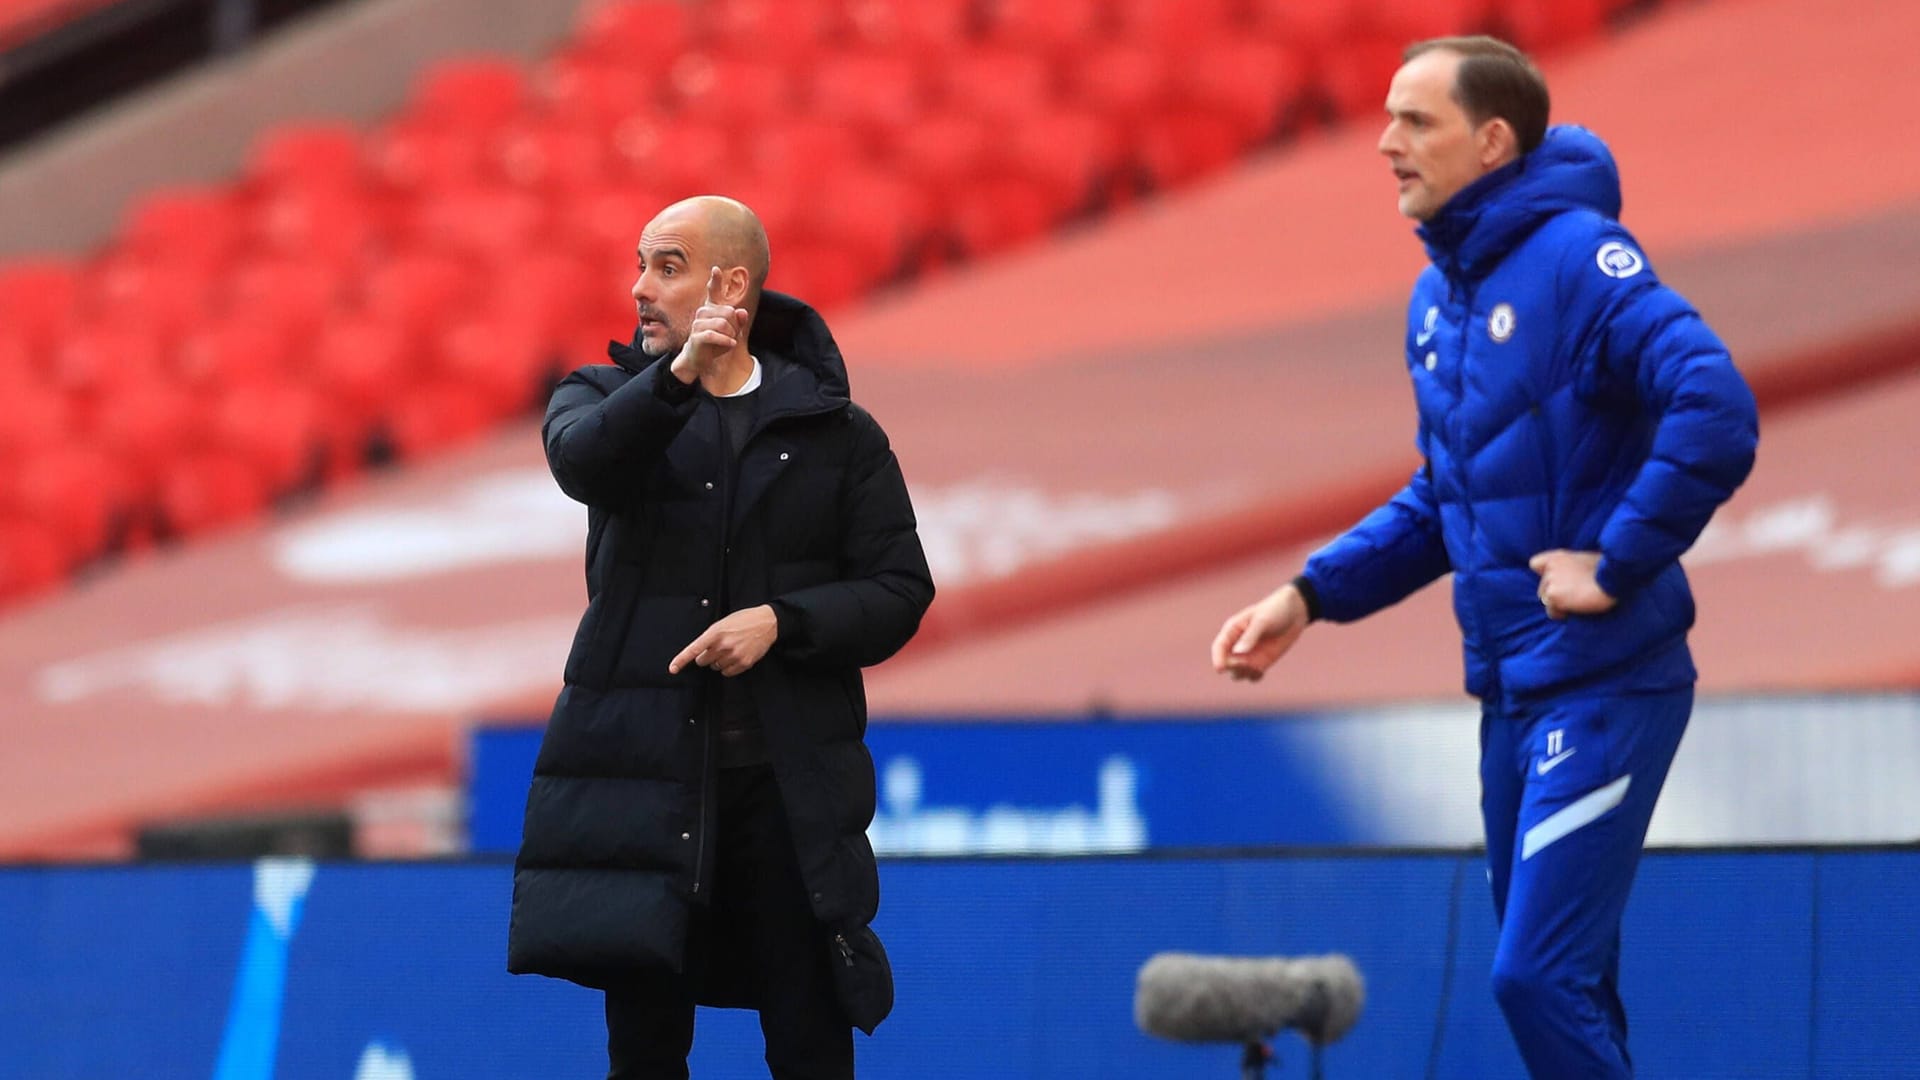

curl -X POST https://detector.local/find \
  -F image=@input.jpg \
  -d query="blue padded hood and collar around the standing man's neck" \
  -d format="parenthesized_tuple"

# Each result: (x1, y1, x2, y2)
(1417, 123, 1620, 279)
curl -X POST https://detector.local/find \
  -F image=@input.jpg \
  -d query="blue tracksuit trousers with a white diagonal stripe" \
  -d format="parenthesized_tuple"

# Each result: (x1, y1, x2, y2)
(1480, 688, 1693, 1080)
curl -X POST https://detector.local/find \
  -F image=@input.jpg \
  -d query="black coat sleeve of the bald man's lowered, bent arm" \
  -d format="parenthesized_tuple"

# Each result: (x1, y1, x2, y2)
(774, 405, 933, 667)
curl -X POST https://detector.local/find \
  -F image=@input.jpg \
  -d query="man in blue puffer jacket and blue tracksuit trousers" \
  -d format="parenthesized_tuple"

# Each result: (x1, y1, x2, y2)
(1213, 38, 1757, 1080)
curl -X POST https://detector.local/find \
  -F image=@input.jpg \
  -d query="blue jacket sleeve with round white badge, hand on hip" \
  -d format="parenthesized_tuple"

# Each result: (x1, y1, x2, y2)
(1563, 227, 1759, 598)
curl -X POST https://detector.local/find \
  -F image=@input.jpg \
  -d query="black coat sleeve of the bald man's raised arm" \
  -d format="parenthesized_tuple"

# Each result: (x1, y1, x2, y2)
(540, 359, 695, 507)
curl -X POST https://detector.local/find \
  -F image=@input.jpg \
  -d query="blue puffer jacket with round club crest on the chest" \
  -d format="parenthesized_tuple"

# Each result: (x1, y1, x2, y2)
(1302, 127, 1759, 703)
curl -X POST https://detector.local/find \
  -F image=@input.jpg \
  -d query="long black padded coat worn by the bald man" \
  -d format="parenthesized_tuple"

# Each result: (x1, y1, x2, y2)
(507, 292, 933, 1005)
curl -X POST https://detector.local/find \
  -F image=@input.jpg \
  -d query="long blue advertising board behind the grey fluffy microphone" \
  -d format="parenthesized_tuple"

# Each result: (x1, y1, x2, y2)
(0, 847, 1920, 1080)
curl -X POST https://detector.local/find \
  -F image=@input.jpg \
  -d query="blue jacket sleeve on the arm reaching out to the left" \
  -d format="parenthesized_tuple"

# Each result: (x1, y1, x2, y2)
(1296, 430, 1452, 623)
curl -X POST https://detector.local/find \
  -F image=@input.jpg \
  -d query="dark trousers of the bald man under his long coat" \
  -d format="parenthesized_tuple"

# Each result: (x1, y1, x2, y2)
(607, 765, 852, 1080)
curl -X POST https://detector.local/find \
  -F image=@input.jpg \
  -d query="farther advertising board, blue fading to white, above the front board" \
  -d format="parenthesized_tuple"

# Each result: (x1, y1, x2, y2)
(468, 694, 1920, 855)
